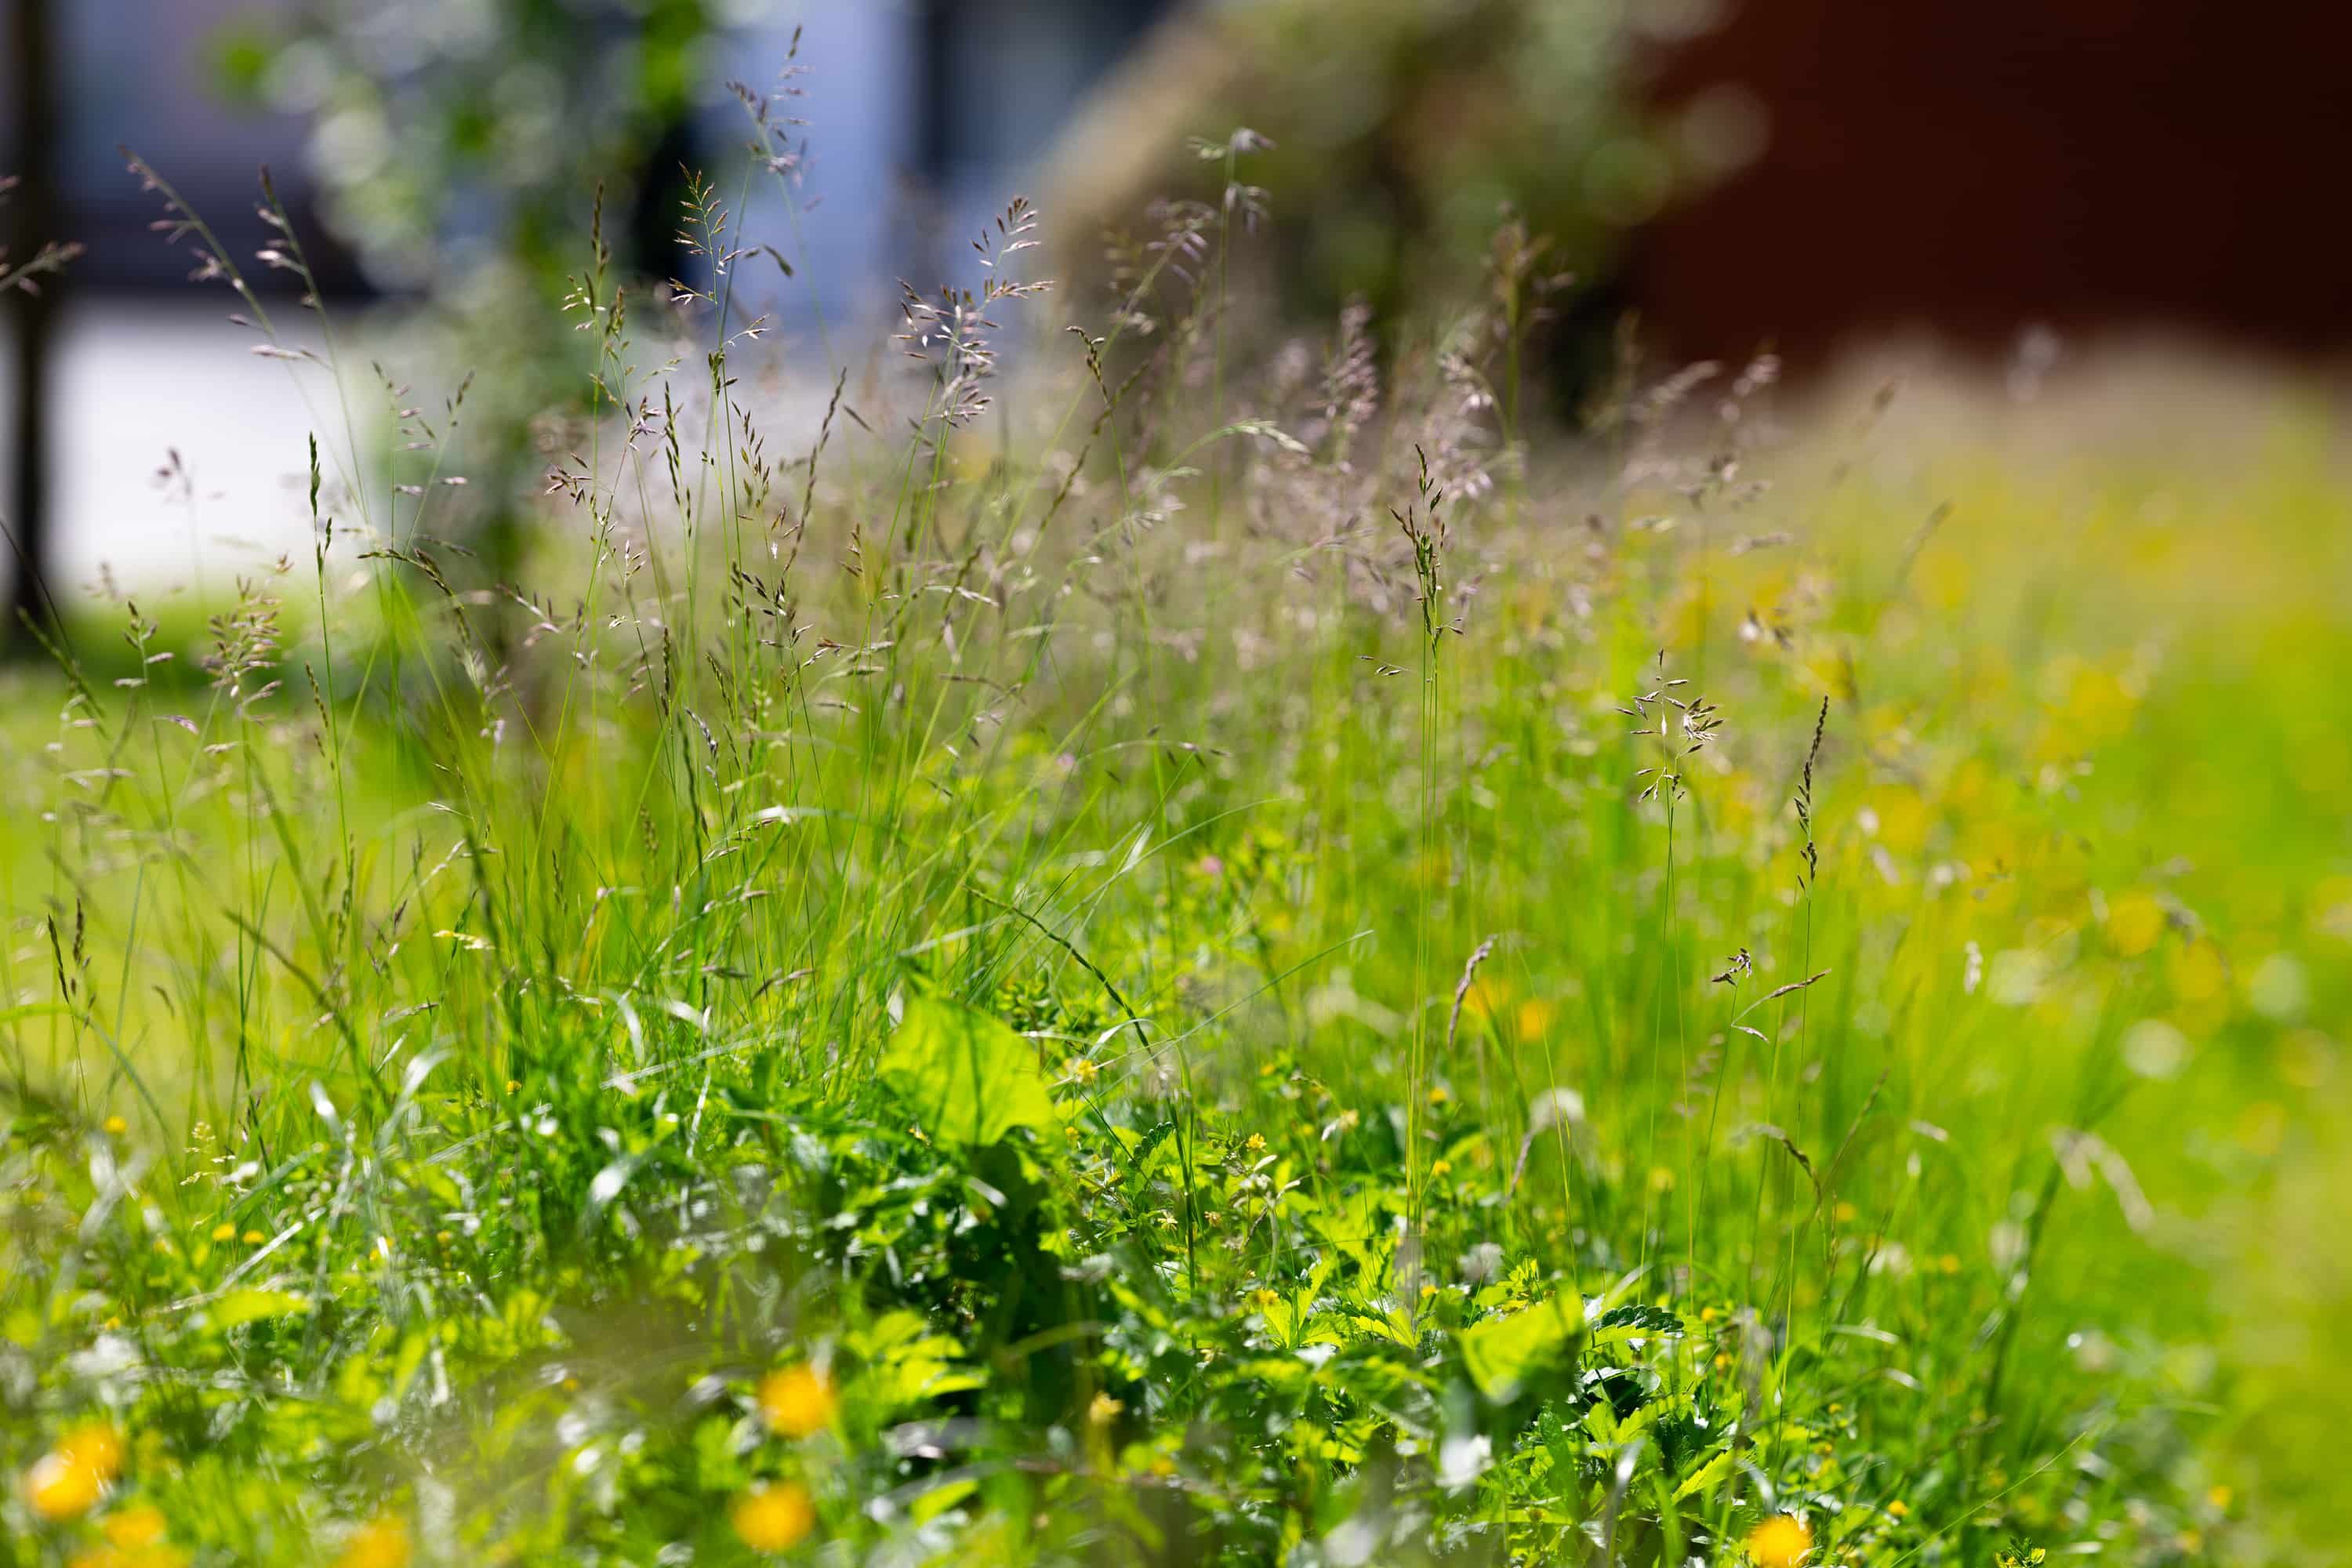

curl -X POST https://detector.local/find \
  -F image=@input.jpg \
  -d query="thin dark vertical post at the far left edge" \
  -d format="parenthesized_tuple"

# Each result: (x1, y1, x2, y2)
(0, 0, 64, 637)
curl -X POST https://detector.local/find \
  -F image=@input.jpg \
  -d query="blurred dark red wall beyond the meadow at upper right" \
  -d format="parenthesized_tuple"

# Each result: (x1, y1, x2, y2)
(1628, 0, 2352, 360)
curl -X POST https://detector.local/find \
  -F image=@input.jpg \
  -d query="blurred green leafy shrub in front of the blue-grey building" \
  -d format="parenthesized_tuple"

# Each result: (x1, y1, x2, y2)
(216, 0, 746, 587)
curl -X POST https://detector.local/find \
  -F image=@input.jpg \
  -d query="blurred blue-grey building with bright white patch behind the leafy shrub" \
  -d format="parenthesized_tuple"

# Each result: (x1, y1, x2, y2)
(0, 0, 1169, 607)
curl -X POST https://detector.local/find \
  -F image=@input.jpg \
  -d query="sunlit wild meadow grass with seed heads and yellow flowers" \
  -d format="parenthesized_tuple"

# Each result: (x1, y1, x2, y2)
(0, 89, 2352, 1568)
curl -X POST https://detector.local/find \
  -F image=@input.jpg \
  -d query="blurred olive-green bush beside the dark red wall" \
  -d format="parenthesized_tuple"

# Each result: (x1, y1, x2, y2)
(1044, 0, 1708, 394)
